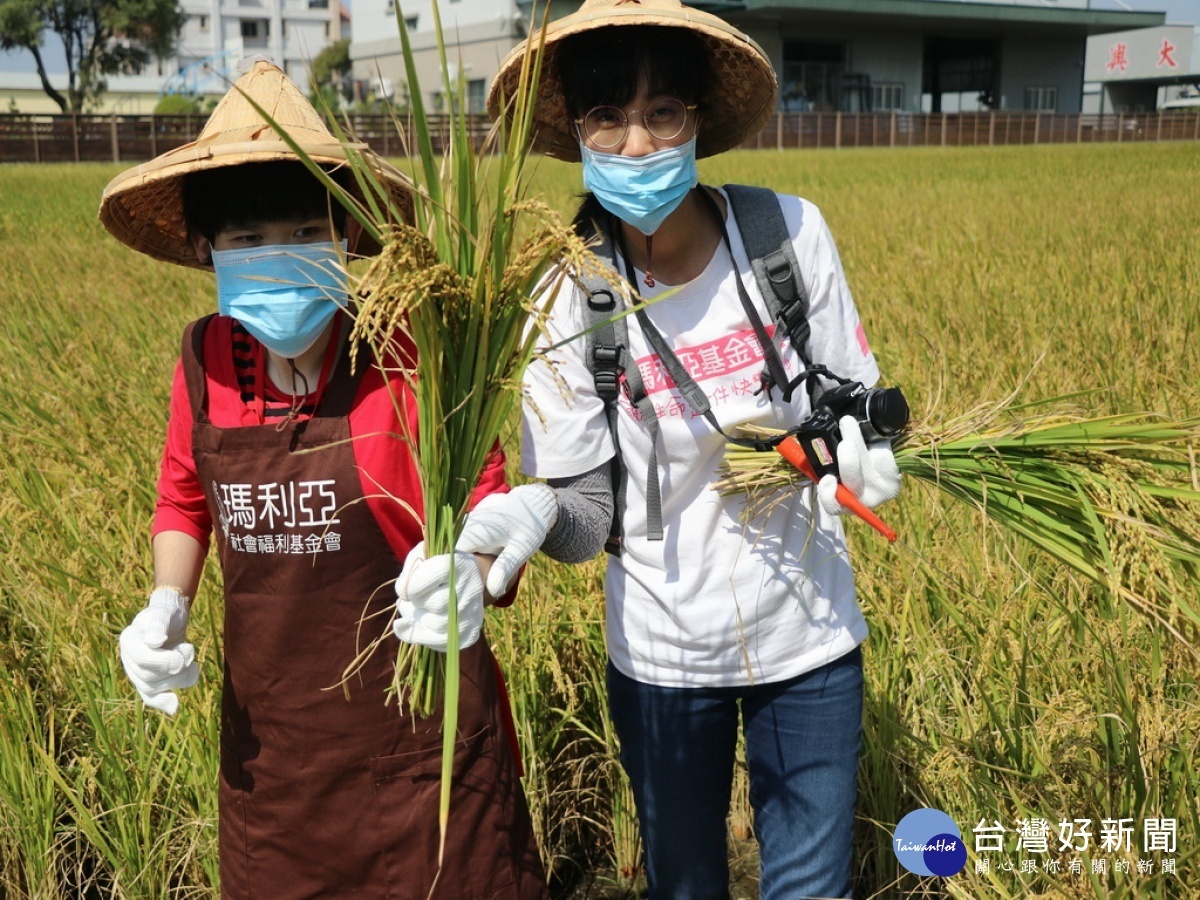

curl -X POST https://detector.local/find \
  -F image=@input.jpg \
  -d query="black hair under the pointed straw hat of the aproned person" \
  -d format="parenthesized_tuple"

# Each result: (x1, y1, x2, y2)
(182, 160, 348, 241)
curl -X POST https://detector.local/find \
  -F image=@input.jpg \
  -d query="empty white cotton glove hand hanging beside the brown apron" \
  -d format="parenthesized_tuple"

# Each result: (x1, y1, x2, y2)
(120, 587, 200, 715)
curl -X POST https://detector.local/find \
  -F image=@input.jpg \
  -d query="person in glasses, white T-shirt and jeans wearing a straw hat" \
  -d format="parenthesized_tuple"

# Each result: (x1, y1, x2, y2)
(477, 0, 900, 900)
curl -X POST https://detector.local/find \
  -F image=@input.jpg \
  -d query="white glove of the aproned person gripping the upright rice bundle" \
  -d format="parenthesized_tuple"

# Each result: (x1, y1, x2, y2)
(391, 541, 484, 653)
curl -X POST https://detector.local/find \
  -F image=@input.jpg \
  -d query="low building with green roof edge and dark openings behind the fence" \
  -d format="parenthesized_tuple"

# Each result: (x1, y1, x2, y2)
(696, 0, 1164, 113)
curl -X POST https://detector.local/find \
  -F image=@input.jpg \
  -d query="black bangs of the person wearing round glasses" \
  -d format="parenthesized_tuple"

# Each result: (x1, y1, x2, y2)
(554, 25, 710, 118)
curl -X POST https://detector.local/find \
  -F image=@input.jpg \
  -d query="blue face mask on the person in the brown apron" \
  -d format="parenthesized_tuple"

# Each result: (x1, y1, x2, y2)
(212, 240, 347, 359)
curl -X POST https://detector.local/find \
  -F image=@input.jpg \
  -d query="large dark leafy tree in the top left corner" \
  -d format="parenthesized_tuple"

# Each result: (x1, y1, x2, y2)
(0, 0, 187, 113)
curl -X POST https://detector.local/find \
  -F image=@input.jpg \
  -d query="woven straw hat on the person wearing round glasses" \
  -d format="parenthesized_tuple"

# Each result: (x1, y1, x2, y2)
(487, 0, 779, 162)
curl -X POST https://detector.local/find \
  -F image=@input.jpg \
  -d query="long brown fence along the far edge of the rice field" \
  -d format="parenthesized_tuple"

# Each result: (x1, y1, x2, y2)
(0, 109, 1200, 163)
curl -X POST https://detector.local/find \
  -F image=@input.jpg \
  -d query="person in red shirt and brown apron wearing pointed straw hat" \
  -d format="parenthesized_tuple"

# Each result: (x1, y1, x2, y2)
(100, 60, 547, 900)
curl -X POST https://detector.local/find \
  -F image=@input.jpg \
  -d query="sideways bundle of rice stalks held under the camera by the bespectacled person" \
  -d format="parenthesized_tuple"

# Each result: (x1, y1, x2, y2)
(718, 397, 1200, 652)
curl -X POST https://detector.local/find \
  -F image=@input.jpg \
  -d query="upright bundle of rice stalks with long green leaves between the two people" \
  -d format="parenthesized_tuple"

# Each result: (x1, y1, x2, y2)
(241, 2, 607, 858)
